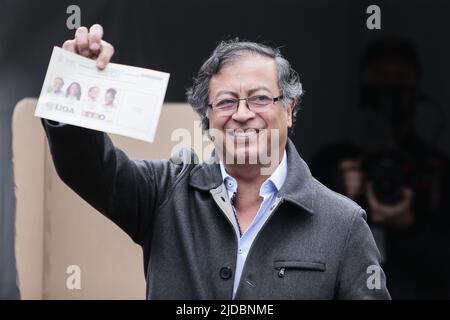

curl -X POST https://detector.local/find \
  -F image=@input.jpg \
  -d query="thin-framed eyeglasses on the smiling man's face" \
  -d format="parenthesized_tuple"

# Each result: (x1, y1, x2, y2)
(208, 95, 283, 115)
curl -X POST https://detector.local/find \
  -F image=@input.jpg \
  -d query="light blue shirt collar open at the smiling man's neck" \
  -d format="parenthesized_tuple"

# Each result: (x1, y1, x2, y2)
(220, 150, 287, 196)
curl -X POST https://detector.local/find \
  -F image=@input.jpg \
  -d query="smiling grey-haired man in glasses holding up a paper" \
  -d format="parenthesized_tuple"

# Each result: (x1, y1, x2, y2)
(43, 25, 390, 299)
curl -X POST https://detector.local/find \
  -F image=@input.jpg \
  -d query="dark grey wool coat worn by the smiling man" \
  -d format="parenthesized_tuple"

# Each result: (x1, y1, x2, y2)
(43, 120, 390, 299)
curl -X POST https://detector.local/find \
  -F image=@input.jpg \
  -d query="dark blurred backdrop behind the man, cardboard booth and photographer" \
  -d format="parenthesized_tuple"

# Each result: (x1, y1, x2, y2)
(0, 0, 450, 298)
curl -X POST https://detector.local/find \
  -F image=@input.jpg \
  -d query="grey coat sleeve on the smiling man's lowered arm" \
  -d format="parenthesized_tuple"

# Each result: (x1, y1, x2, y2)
(336, 208, 391, 300)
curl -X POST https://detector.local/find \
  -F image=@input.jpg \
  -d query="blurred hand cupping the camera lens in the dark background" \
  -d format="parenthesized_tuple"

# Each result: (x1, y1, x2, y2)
(366, 183, 414, 227)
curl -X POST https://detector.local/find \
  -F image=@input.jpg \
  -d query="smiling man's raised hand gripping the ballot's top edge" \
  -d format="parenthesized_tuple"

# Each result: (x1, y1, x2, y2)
(63, 24, 114, 69)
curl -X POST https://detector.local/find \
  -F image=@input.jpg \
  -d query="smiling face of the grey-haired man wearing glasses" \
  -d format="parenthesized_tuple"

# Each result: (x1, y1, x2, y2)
(209, 54, 294, 164)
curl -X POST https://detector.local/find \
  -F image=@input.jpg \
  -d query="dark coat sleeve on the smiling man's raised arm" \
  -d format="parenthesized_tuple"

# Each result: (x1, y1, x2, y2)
(42, 119, 173, 245)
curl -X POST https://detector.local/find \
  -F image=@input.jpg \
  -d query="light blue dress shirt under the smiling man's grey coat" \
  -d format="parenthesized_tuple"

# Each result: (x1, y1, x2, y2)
(220, 151, 287, 299)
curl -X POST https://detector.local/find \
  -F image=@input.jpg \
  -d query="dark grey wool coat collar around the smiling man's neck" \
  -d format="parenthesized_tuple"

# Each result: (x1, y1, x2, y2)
(189, 139, 314, 214)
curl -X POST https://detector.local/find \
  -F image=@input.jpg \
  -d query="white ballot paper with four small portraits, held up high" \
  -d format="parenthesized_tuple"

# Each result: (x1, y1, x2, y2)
(35, 47, 170, 142)
